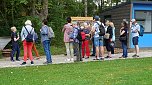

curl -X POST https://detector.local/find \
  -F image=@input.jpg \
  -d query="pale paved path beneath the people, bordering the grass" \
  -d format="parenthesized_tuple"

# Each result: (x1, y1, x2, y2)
(0, 51, 152, 68)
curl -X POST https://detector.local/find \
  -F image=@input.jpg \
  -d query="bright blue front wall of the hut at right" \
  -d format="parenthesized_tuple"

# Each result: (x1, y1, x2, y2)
(130, 2, 152, 48)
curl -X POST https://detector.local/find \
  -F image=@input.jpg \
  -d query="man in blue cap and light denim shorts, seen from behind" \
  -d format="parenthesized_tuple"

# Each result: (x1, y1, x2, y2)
(92, 16, 104, 60)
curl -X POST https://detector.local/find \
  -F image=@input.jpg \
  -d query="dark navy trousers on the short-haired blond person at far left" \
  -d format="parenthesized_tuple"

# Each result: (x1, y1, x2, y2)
(11, 43, 20, 60)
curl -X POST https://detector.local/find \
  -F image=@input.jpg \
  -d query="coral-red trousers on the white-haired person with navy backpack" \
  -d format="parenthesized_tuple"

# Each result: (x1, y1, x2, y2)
(23, 40, 33, 62)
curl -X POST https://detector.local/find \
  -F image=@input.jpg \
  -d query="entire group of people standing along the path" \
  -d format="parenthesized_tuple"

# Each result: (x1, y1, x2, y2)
(11, 16, 140, 65)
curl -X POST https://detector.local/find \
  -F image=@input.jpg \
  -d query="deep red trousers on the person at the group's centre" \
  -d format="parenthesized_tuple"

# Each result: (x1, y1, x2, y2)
(82, 40, 90, 57)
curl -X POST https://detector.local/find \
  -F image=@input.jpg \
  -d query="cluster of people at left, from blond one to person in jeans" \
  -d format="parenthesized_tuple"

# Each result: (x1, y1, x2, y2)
(11, 19, 52, 65)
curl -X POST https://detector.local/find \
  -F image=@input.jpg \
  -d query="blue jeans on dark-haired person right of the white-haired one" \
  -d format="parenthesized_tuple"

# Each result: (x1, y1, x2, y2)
(43, 40, 52, 63)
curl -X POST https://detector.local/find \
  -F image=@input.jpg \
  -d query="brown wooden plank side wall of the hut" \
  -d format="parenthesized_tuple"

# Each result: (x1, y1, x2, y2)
(101, 4, 131, 47)
